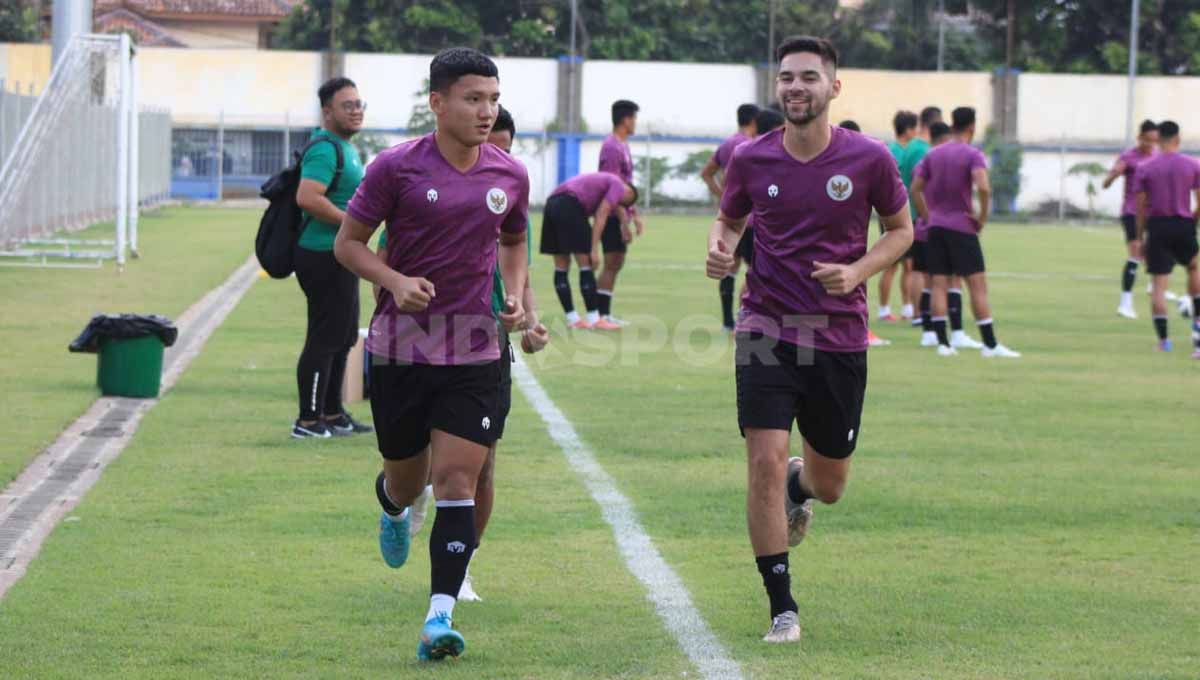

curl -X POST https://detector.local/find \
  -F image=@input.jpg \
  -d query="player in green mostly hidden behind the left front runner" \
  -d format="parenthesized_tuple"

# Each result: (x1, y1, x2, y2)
(376, 107, 550, 602)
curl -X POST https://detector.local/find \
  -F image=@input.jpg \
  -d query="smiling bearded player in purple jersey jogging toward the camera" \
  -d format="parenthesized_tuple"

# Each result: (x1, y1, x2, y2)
(706, 37, 912, 643)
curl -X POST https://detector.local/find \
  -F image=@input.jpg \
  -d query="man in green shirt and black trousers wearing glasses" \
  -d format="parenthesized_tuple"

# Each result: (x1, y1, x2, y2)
(292, 78, 372, 439)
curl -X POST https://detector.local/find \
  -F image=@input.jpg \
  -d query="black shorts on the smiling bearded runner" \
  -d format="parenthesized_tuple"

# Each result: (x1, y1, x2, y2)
(734, 332, 866, 458)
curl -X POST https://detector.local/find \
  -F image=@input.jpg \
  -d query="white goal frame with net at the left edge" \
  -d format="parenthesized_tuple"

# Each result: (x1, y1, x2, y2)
(0, 34, 140, 266)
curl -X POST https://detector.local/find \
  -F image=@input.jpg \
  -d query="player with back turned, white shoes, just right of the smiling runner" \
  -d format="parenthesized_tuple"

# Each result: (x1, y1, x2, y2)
(912, 107, 1021, 359)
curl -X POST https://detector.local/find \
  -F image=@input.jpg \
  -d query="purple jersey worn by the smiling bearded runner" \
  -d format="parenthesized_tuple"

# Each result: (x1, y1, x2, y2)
(721, 127, 908, 351)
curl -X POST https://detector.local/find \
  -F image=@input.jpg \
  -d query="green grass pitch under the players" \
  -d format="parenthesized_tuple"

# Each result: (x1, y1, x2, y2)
(0, 210, 1200, 680)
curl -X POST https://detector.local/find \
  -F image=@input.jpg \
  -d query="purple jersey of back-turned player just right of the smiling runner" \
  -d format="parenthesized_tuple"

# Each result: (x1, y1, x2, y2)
(912, 142, 988, 234)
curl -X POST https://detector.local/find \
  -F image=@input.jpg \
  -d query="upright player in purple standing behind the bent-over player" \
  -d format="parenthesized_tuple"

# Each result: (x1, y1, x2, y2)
(592, 100, 646, 331)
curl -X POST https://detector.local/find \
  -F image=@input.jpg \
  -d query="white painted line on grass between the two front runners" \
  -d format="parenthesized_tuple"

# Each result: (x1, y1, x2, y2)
(512, 360, 742, 680)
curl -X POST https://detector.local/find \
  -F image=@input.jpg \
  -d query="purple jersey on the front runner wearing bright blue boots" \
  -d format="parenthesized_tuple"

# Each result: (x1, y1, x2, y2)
(346, 134, 529, 365)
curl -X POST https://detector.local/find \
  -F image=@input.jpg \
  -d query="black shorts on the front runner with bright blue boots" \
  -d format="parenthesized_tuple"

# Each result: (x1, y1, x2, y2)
(371, 356, 509, 461)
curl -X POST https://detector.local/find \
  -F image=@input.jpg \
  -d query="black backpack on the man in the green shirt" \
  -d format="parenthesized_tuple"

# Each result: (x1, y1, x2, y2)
(254, 137, 342, 278)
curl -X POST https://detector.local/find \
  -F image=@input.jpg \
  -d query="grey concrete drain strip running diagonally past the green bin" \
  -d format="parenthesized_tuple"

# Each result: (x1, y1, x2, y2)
(0, 255, 258, 598)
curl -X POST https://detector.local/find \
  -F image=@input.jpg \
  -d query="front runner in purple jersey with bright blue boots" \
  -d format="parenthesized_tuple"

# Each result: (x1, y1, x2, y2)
(335, 48, 529, 660)
